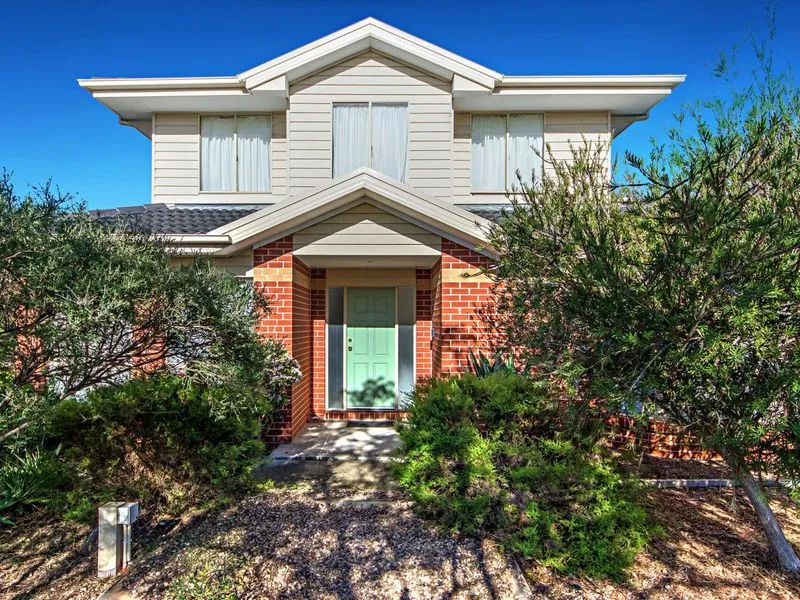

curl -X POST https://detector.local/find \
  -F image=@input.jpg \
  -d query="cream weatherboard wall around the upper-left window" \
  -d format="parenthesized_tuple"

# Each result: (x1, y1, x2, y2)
(152, 113, 287, 204)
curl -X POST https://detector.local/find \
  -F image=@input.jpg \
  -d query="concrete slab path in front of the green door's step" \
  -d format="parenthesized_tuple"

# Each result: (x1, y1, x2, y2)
(270, 421, 400, 461)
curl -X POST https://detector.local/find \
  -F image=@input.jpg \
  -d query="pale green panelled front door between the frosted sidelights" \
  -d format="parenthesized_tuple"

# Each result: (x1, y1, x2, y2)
(345, 288, 397, 408)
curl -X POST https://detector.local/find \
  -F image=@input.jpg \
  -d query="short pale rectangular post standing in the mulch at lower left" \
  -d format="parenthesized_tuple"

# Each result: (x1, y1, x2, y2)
(97, 502, 139, 578)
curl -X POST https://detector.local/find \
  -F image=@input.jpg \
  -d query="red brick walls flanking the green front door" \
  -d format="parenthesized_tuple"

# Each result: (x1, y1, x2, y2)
(253, 236, 492, 445)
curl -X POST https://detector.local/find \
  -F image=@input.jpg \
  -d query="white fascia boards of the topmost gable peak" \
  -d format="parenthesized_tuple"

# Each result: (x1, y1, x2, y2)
(239, 18, 503, 89)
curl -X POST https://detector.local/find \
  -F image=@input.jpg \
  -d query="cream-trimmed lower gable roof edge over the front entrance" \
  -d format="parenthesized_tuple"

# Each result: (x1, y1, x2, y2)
(208, 168, 492, 256)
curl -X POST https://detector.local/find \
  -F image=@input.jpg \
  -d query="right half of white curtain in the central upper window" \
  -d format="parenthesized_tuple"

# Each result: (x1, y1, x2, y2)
(372, 104, 408, 181)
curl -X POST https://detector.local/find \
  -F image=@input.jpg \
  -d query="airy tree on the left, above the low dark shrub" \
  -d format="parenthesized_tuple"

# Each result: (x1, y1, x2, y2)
(0, 173, 297, 441)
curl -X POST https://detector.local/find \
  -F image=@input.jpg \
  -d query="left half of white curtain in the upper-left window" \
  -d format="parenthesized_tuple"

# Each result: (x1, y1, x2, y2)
(200, 117, 235, 192)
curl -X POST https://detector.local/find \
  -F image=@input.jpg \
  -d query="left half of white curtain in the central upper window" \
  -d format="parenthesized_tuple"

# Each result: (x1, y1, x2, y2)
(333, 104, 369, 177)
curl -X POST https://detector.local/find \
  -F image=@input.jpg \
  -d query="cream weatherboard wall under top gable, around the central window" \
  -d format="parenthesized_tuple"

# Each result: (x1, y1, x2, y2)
(288, 51, 453, 200)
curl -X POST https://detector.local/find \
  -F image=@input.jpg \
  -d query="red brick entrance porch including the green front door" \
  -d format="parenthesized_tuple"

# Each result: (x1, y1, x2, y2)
(254, 235, 492, 446)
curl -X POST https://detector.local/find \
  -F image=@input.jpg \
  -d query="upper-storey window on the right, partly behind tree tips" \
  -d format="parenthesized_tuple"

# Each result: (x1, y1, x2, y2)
(472, 115, 544, 192)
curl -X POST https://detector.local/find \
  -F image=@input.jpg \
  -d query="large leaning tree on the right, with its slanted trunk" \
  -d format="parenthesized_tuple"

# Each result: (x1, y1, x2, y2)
(490, 48, 800, 572)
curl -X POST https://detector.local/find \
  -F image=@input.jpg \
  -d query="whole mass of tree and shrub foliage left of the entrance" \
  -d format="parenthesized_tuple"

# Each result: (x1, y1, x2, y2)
(0, 172, 299, 518)
